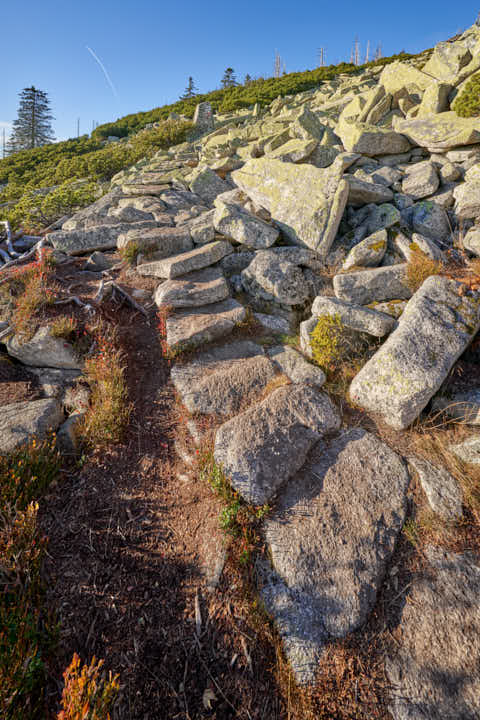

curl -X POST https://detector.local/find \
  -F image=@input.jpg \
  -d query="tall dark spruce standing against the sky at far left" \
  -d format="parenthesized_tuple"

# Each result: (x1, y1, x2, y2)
(9, 85, 55, 152)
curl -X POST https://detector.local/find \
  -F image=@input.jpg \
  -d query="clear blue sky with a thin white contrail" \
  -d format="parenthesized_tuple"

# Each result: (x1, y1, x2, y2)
(0, 0, 480, 139)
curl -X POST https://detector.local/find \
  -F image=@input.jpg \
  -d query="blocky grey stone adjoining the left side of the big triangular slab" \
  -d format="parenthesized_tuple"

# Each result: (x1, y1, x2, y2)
(213, 203, 279, 250)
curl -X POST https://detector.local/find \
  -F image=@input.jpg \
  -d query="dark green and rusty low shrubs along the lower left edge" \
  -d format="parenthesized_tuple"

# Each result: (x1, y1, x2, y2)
(0, 438, 60, 720)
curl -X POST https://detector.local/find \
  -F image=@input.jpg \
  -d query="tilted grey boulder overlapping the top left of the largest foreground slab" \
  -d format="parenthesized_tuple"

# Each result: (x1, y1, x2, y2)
(214, 384, 340, 505)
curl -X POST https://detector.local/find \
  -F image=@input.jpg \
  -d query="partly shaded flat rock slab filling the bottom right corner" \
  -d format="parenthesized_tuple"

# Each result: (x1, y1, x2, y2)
(387, 547, 480, 720)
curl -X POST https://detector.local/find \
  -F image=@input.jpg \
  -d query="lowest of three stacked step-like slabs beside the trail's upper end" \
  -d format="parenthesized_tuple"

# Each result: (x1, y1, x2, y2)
(166, 299, 246, 352)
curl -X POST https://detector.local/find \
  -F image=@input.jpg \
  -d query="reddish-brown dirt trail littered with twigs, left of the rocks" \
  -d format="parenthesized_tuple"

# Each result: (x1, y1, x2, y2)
(41, 296, 287, 720)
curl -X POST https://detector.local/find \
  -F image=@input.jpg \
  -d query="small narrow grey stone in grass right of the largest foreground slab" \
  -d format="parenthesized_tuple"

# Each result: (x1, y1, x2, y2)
(408, 457, 463, 521)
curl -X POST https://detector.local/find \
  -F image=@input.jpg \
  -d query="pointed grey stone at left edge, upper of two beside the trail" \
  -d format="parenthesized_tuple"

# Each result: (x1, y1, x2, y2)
(7, 326, 83, 370)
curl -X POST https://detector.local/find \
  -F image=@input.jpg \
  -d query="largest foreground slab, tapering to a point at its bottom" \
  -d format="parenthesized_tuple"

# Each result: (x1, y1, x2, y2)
(262, 429, 409, 683)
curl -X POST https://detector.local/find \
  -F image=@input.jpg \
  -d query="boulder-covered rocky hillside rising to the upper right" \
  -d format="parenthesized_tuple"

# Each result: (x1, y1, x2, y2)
(2, 15, 480, 720)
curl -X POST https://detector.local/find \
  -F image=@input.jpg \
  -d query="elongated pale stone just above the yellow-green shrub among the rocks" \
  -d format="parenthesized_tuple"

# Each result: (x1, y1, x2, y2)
(312, 295, 397, 337)
